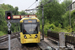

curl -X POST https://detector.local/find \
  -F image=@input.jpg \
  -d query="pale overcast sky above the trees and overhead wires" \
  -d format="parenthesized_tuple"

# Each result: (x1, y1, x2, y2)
(0, 0, 75, 11)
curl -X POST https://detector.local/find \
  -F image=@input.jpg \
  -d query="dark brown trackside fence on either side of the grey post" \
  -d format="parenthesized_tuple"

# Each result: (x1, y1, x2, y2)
(47, 30, 75, 47)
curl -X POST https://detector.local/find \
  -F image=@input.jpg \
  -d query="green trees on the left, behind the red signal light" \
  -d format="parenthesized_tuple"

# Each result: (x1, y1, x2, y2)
(0, 3, 26, 36)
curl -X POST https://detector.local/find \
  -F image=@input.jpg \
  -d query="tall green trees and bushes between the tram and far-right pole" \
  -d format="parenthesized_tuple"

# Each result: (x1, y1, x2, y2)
(36, 0, 72, 34)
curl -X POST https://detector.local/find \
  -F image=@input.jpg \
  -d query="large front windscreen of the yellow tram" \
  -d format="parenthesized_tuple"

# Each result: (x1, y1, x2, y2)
(23, 24, 38, 34)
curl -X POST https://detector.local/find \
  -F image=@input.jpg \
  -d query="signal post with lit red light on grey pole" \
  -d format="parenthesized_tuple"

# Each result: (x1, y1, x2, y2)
(5, 11, 12, 50)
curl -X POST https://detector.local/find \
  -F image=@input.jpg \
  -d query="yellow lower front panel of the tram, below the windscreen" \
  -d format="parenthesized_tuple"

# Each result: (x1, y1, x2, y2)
(20, 32, 40, 44)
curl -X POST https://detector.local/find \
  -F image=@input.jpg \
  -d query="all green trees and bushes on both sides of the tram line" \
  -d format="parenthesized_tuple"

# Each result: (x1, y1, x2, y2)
(0, 0, 75, 36)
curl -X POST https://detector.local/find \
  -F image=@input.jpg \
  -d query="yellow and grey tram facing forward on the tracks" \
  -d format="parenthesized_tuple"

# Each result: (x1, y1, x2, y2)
(20, 17, 40, 44)
